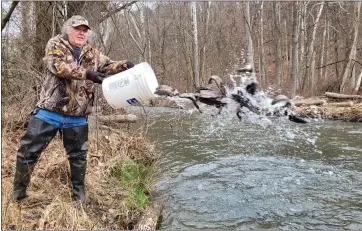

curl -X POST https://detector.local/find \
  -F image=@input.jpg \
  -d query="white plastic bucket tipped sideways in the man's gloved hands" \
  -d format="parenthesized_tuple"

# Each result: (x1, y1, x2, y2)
(102, 62, 158, 108)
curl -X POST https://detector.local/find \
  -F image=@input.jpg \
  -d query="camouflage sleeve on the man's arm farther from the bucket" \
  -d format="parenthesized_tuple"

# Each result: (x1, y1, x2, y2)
(43, 42, 86, 80)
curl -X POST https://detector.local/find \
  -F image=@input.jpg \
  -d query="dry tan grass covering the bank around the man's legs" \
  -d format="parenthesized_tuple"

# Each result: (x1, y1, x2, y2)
(1, 120, 157, 230)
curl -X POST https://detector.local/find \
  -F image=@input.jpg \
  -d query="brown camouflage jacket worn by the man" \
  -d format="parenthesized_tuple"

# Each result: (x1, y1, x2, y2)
(36, 35, 124, 116)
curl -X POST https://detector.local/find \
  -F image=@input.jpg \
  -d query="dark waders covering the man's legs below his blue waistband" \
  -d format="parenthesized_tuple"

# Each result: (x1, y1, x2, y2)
(13, 115, 88, 203)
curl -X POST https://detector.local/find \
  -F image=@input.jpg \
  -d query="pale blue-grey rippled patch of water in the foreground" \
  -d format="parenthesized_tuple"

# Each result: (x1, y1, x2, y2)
(163, 156, 362, 229)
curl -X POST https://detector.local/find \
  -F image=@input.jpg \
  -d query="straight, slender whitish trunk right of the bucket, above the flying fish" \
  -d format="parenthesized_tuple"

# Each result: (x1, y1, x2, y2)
(191, 2, 200, 88)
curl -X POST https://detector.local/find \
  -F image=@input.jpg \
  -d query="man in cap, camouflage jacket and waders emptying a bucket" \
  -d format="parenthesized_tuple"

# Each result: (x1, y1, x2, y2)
(13, 15, 134, 203)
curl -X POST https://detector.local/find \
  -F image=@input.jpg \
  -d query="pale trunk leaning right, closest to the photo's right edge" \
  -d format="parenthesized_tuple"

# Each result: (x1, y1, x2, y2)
(339, 2, 362, 93)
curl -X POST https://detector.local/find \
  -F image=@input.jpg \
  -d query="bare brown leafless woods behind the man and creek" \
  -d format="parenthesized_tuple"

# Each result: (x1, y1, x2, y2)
(1, 1, 362, 118)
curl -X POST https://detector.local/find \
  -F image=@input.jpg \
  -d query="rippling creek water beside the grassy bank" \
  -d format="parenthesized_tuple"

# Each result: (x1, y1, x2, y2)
(129, 105, 362, 230)
